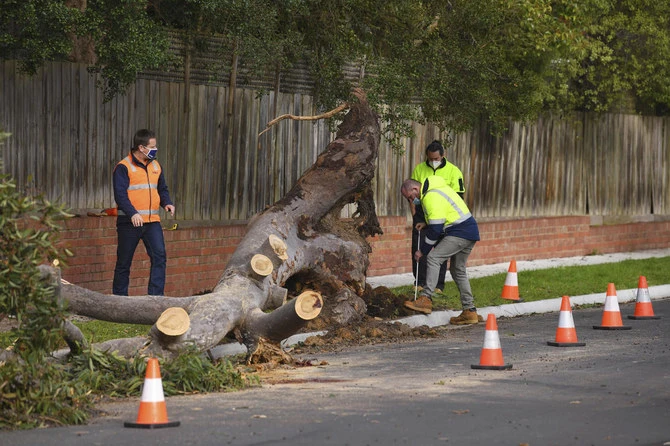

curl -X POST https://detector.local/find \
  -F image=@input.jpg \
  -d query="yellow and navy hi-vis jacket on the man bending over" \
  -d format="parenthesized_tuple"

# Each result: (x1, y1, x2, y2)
(420, 175, 479, 254)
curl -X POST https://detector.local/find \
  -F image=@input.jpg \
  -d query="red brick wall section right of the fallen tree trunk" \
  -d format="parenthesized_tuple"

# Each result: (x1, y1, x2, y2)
(368, 216, 670, 277)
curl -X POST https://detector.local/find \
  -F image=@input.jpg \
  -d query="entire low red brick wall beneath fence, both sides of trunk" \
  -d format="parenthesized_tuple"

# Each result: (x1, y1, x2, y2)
(61, 216, 670, 296)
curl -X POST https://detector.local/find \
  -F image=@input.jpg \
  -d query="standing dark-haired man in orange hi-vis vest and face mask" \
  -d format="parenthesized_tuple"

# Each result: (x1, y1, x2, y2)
(112, 129, 174, 296)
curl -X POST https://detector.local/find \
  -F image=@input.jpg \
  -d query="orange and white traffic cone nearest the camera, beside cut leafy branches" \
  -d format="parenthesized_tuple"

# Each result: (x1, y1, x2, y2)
(123, 358, 179, 429)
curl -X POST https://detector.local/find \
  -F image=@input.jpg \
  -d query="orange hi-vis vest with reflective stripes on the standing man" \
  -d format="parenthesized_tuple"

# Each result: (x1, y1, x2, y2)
(119, 155, 161, 223)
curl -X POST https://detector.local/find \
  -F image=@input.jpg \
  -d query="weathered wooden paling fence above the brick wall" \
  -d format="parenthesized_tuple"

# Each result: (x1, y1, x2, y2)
(0, 61, 670, 222)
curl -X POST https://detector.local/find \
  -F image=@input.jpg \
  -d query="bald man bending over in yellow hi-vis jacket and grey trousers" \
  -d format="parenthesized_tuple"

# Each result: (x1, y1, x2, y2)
(400, 175, 483, 325)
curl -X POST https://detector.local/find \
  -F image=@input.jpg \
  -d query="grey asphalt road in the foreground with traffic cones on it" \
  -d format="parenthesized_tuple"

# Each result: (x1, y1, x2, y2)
(5, 299, 670, 446)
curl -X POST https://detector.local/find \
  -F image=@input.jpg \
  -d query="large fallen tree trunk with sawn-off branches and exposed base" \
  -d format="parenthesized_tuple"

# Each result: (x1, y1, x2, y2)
(55, 92, 381, 356)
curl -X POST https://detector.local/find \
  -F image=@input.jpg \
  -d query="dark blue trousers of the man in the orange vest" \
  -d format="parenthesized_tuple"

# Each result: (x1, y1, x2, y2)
(112, 221, 167, 296)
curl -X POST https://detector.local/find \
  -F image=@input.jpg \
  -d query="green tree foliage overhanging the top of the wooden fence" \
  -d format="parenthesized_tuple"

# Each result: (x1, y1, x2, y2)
(0, 0, 670, 133)
